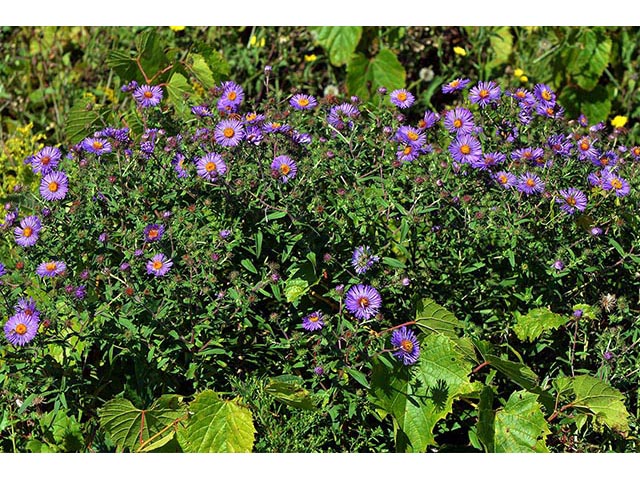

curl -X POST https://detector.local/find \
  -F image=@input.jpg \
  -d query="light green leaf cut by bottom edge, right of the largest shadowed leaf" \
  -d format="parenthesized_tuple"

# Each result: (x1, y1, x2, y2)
(494, 390, 551, 453)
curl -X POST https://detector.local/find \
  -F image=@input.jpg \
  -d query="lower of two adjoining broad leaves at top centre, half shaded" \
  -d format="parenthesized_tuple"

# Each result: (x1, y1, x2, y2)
(347, 50, 406, 100)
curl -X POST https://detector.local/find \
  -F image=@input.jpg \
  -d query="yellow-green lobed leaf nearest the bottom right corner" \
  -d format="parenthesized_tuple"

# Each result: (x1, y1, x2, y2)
(571, 375, 629, 432)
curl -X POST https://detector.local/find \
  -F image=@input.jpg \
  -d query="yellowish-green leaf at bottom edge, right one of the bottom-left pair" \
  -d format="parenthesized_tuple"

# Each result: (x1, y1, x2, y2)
(177, 390, 255, 453)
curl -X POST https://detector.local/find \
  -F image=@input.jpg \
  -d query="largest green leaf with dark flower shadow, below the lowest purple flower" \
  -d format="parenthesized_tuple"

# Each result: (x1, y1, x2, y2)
(370, 334, 474, 452)
